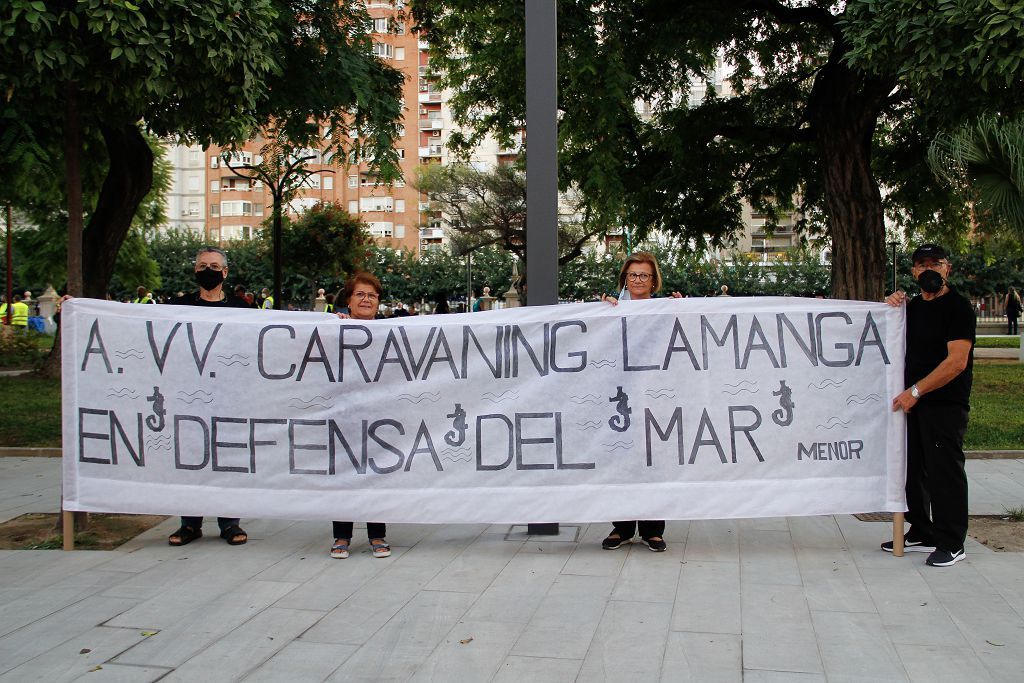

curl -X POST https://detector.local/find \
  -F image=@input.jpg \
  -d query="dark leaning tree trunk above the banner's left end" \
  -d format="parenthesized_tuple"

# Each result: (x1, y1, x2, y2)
(83, 124, 153, 299)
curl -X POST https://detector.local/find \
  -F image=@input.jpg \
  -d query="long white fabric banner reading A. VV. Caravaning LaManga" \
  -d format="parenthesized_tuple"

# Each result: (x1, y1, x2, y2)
(62, 297, 906, 523)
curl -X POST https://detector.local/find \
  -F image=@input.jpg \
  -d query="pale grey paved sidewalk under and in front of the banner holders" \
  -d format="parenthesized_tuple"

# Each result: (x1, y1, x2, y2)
(0, 458, 1024, 683)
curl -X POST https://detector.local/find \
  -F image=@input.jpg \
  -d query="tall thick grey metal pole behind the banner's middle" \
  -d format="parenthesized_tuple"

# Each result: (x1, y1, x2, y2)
(526, 0, 558, 536)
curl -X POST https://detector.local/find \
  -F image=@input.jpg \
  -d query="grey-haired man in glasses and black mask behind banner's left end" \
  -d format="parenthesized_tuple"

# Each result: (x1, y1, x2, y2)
(167, 247, 249, 546)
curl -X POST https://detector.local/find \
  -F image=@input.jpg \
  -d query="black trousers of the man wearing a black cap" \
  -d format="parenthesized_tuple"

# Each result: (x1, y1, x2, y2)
(906, 403, 968, 552)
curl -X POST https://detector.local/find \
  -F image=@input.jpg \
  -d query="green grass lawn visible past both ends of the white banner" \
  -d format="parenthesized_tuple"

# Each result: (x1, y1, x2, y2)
(0, 362, 1024, 451)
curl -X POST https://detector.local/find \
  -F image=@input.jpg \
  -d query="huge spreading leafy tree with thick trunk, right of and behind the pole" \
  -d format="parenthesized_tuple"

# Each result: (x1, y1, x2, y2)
(413, 0, 1024, 300)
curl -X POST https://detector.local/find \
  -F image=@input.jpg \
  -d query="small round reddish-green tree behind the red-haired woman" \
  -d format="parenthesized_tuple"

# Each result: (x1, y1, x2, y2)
(260, 204, 373, 307)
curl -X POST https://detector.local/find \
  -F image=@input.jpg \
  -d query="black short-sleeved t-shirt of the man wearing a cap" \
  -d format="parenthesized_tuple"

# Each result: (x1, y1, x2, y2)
(905, 289, 975, 408)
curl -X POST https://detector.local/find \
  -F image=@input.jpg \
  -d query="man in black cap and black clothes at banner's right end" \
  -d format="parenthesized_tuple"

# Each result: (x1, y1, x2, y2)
(882, 244, 975, 567)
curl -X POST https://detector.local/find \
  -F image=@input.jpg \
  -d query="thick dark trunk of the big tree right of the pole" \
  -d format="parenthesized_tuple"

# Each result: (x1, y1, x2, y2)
(808, 52, 894, 301)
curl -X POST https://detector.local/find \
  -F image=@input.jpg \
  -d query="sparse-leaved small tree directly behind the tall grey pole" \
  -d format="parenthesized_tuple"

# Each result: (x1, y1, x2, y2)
(415, 164, 607, 286)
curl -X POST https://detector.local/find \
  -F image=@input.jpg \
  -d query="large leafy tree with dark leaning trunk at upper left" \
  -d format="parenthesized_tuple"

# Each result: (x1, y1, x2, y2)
(0, 0, 402, 297)
